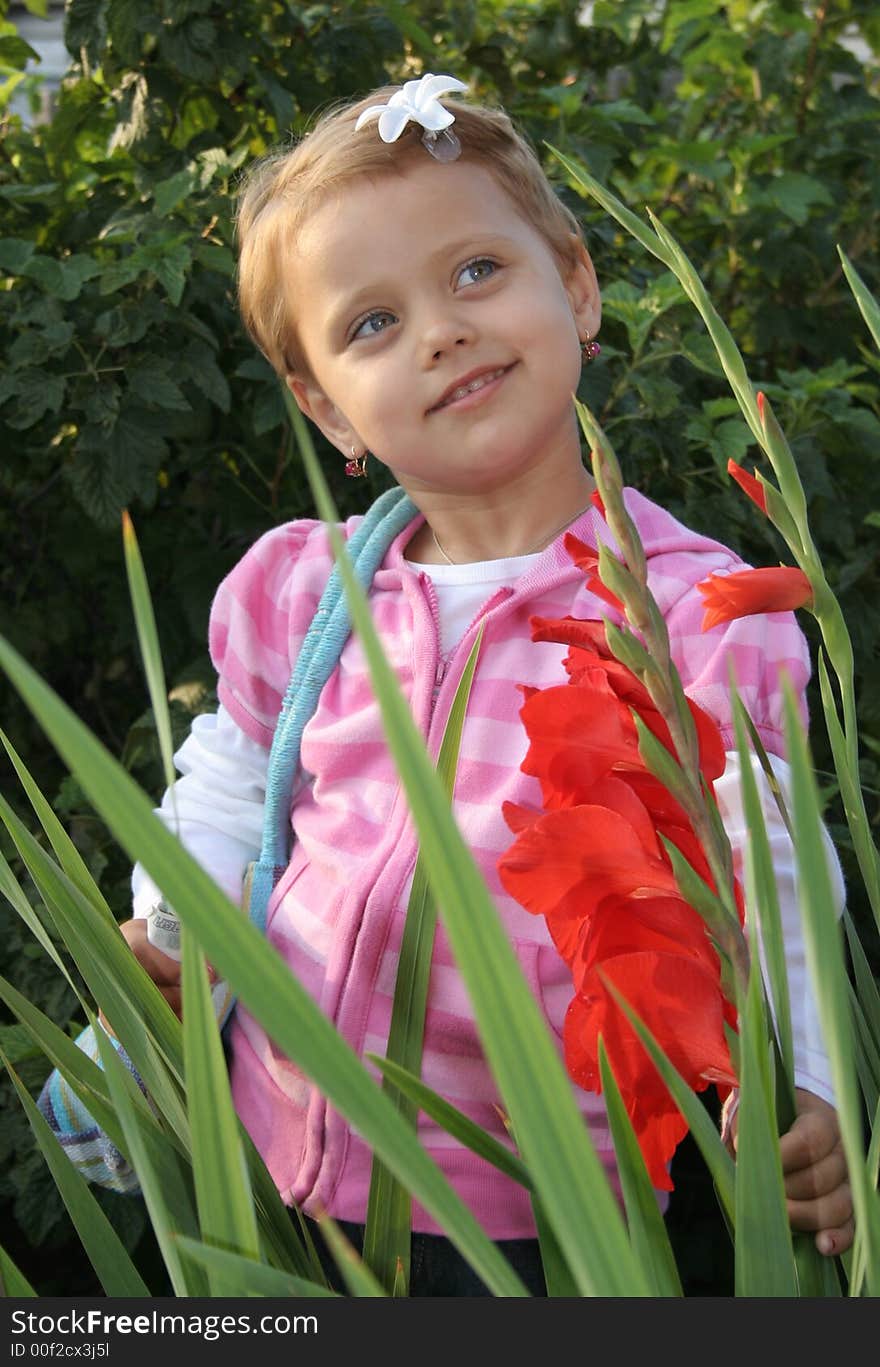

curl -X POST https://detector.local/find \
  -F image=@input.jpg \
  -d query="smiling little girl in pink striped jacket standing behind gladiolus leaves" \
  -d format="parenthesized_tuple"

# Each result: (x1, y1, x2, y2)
(118, 77, 851, 1295)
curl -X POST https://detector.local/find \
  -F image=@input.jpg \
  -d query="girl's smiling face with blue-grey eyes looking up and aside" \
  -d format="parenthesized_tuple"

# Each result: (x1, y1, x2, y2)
(286, 154, 600, 500)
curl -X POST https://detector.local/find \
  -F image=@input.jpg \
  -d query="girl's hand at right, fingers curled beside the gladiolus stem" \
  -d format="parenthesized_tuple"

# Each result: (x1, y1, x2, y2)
(727, 1087, 854, 1258)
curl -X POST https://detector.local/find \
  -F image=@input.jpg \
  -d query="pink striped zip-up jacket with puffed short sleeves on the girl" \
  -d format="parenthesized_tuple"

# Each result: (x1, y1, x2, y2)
(210, 491, 809, 1239)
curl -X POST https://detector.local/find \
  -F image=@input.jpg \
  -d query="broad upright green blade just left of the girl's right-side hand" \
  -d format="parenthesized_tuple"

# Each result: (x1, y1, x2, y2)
(734, 956, 798, 1297)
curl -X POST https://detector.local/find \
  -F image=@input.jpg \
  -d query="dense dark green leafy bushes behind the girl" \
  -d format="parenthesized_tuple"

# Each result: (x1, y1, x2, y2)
(0, 0, 880, 1295)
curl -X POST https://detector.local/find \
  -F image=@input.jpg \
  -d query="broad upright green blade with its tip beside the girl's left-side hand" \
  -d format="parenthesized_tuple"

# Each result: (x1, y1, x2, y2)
(182, 928, 260, 1296)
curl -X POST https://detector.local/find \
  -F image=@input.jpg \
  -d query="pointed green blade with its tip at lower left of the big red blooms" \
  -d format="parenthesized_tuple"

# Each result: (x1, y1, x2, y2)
(599, 1038, 683, 1296)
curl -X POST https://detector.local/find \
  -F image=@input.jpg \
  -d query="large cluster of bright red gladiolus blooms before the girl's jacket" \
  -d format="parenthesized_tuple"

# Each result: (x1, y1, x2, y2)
(499, 536, 743, 1189)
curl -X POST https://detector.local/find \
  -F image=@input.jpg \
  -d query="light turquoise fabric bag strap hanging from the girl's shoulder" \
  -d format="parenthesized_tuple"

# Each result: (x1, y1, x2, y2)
(247, 488, 418, 931)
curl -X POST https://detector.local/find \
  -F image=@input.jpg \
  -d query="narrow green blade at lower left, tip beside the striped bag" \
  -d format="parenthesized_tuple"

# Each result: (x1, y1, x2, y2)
(97, 1031, 208, 1296)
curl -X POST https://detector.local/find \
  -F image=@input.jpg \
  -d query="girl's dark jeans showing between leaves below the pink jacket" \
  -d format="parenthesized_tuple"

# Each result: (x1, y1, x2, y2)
(306, 1215, 547, 1296)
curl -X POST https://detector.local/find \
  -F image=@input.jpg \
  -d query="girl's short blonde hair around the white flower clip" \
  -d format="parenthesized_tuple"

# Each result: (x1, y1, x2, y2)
(236, 86, 582, 376)
